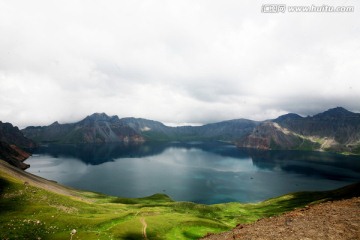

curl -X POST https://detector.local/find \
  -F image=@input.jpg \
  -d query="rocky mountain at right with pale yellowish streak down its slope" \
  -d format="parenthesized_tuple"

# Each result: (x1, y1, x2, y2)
(236, 107, 360, 154)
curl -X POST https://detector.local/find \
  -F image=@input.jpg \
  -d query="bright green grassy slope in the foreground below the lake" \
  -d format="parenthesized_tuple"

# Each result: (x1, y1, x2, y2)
(0, 160, 360, 239)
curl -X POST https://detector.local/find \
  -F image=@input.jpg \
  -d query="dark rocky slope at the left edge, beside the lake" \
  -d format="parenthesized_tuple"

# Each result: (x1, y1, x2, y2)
(0, 121, 36, 169)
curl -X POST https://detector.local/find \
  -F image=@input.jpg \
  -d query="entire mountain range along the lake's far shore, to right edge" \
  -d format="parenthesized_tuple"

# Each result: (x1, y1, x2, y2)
(22, 107, 360, 154)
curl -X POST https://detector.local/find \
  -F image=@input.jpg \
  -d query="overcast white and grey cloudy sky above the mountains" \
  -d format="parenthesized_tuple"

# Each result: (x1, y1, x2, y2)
(0, 0, 360, 128)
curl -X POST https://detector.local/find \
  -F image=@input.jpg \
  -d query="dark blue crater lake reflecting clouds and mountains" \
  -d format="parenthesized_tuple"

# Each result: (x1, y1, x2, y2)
(26, 142, 360, 204)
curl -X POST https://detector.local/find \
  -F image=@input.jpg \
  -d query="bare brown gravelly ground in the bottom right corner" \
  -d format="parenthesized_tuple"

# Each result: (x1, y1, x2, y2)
(203, 198, 360, 240)
